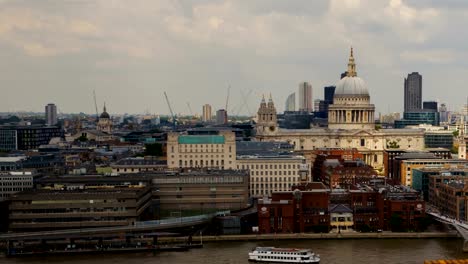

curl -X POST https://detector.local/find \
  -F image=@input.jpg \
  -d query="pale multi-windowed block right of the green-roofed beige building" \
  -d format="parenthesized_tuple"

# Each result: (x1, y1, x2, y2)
(236, 155, 310, 197)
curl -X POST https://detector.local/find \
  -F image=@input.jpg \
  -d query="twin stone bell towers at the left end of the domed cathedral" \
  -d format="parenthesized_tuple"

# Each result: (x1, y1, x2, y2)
(256, 94, 278, 135)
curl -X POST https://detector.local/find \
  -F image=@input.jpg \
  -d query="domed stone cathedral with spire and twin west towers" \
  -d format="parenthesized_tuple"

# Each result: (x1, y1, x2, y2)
(256, 48, 425, 173)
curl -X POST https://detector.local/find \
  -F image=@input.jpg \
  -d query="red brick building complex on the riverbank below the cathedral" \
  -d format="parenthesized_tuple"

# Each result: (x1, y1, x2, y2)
(258, 183, 425, 234)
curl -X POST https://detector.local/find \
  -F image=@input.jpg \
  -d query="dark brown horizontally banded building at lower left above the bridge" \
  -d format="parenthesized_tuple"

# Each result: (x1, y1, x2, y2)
(9, 186, 151, 232)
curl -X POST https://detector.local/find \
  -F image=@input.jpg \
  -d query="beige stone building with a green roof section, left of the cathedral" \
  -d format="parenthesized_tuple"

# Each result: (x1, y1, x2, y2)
(167, 131, 236, 169)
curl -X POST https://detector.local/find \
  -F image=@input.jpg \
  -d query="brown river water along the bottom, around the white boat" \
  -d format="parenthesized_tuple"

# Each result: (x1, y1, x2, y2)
(0, 239, 468, 264)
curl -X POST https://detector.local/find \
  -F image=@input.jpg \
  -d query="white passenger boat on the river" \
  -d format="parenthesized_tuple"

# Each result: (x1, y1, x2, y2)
(249, 247, 320, 263)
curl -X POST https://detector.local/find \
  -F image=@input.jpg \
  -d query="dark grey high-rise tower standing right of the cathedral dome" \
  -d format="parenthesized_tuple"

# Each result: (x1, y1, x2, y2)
(404, 72, 422, 112)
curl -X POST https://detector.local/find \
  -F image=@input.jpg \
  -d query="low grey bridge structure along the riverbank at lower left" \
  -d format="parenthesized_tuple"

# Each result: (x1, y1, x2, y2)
(0, 211, 230, 242)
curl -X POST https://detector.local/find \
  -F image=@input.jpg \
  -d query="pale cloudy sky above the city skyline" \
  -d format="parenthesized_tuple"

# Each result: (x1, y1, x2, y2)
(0, 0, 468, 115)
